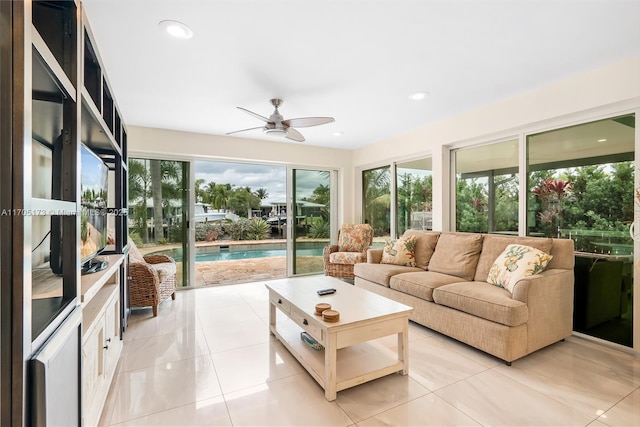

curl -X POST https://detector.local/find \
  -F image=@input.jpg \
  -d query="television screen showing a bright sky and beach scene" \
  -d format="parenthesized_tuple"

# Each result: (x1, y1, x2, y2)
(80, 145, 109, 270)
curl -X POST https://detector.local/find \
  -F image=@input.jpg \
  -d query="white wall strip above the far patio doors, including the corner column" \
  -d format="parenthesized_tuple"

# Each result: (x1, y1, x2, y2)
(127, 126, 355, 223)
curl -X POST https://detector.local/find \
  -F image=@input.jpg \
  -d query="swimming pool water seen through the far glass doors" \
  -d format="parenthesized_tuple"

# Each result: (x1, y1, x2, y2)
(154, 242, 327, 262)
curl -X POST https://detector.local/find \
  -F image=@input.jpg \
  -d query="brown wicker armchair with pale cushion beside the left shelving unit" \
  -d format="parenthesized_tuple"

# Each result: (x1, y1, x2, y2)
(129, 240, 176, 317)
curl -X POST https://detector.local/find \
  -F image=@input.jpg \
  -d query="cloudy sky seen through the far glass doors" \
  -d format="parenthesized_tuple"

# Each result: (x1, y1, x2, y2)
(195, 161, 327, 204)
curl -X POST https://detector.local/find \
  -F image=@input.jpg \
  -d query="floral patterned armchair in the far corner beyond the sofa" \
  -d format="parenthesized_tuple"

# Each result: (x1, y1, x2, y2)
(323, 224, 373, 279)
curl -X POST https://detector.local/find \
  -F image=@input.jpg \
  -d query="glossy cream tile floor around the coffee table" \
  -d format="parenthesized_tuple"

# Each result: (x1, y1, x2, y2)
(101, 282, 640, 426)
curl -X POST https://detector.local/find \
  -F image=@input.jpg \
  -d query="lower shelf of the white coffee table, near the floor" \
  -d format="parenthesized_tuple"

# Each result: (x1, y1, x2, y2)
(270, 316, 406, 400)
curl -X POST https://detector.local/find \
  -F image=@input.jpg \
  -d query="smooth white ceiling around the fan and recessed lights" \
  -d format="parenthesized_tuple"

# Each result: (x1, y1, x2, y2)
(83, 0, 640, 149)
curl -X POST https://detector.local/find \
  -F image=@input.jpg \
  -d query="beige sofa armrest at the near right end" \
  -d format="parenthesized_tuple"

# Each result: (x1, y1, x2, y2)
(513, 269, 574, 351)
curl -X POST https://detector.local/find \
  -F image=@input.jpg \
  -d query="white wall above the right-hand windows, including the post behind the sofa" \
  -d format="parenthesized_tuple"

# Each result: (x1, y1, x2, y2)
(353, 57, 640, 230)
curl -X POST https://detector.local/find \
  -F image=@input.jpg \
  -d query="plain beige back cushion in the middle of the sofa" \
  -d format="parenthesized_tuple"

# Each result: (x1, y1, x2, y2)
(429, 233, 482, 281)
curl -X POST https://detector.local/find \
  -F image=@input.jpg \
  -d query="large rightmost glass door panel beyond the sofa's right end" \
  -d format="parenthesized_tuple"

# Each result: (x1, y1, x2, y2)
(527, 114, 638, 347)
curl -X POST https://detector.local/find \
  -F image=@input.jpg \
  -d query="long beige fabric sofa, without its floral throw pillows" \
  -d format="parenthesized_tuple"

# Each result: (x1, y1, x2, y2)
(354, 230, 575, 365)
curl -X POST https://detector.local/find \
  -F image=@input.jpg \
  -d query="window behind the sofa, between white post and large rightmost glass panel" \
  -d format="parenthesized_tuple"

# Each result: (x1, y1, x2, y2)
(454, 139, 519, 234)
